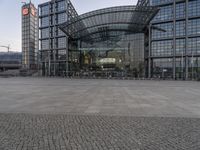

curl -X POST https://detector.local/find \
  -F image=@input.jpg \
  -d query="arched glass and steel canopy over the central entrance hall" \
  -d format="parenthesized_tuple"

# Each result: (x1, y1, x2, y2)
(60, 5, 159, 41)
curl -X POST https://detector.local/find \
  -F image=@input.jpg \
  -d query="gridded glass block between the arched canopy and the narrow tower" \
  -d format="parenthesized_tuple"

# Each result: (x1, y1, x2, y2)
(38, 0, 78, 76)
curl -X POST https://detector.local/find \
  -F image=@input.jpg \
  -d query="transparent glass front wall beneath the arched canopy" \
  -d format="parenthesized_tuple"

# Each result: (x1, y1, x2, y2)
(69, 32, 144, 77)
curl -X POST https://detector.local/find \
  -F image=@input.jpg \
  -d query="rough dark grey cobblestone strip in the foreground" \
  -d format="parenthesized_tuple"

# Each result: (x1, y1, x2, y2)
(0, 113, 200, 150)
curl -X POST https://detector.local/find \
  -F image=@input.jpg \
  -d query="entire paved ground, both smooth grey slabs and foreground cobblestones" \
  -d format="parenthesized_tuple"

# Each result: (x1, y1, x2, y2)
(0, 78, 200, 150)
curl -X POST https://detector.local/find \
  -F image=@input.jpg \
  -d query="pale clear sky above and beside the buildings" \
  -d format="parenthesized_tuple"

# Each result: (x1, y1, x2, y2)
(0, 0, 137, 51)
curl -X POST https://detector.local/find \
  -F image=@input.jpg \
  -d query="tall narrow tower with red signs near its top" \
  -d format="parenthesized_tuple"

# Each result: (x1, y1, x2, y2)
(22, 2, 38, 69)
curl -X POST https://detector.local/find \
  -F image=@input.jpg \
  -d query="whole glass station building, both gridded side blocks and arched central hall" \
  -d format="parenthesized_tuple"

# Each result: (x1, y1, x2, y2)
(39, 0, 200, 79)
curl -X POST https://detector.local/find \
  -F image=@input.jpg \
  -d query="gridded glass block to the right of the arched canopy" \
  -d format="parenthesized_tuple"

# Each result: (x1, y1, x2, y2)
(147, 0, 200, 79)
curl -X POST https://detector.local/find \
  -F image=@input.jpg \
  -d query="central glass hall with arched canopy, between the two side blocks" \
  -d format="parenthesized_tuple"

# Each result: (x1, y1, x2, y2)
(57, 6, 159, 77)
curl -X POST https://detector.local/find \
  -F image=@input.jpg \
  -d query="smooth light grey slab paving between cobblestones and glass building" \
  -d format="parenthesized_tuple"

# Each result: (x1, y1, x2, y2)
(0, 78, 200, 118)
